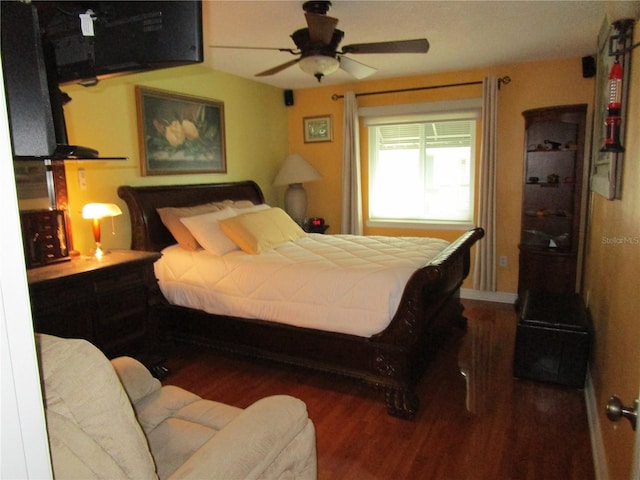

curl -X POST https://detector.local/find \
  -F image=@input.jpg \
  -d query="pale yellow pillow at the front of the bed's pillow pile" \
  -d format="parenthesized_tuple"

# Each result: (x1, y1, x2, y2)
(220, 207, 307, 254)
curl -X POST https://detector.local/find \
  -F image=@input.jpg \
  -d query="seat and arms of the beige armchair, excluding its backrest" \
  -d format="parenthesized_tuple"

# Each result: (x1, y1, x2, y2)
(112, 357, 317, 479)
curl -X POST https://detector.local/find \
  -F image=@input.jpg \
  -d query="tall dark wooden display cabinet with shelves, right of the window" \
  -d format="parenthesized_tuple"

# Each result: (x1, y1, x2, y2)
(518, 105, 587, 295)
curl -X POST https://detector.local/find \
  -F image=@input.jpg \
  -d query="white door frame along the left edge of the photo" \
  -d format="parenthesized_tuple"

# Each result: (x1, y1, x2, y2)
(0, 54, 52, 479)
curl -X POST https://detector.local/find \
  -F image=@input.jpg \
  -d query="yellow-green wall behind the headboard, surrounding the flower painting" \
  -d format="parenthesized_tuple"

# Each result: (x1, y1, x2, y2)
(63, 66, 288, 254)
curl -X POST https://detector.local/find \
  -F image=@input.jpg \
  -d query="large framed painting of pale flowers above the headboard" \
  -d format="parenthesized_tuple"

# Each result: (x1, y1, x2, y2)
(136, 86, 227, 176)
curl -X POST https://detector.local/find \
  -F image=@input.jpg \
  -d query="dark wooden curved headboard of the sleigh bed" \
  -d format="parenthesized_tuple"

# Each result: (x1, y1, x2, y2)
(118, 180, 264, 252)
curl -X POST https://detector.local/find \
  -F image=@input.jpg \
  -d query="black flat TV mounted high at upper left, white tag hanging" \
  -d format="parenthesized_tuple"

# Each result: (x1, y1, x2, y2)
(34, 0, 204, 84)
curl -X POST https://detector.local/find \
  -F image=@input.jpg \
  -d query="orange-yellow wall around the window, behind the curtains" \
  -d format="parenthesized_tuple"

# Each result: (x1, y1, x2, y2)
(289, 58, 594, 292)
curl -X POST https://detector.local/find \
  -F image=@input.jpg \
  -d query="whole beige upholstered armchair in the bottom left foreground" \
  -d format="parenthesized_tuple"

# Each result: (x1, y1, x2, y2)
(37, 335, 317, 479)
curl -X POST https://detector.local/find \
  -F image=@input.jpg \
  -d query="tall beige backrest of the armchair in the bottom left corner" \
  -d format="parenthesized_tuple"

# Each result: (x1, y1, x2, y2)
(37, 335, 157, 479)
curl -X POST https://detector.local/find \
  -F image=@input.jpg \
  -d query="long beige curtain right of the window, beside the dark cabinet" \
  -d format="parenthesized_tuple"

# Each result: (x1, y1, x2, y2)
(473, 77, 498, 292)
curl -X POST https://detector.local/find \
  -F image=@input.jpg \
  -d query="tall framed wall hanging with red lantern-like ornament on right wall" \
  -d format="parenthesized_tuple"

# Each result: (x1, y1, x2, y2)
(591, 19, 634, 200)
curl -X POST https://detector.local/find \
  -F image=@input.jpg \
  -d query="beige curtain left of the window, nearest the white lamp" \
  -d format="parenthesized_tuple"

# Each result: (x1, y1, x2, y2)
(340, 92, 363, 235)
